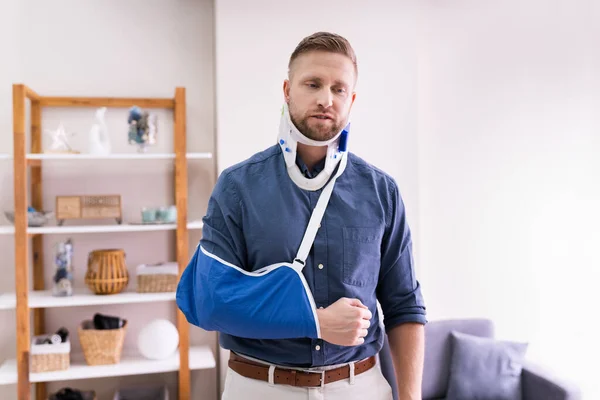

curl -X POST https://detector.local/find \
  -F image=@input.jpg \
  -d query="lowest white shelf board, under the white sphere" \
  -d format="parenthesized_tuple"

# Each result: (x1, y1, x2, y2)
(0, 346, 216, 385)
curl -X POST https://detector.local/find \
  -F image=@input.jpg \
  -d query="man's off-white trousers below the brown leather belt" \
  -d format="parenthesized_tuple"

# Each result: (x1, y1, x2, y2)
(221, 356, 392, 400)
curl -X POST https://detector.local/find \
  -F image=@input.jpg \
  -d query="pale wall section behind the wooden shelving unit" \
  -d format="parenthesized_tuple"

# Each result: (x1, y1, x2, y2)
(0, 0, 217, 399)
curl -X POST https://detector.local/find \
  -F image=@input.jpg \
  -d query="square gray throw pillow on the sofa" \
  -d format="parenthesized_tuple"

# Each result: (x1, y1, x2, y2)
(446, 332, 527, 400)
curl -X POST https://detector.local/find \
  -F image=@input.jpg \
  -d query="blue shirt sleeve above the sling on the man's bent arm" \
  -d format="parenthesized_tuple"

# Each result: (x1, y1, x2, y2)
(200, 171, 249, 270)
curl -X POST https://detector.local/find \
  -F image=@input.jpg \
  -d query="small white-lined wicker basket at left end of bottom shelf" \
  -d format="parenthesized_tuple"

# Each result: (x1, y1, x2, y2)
(30, 335, 71, 373)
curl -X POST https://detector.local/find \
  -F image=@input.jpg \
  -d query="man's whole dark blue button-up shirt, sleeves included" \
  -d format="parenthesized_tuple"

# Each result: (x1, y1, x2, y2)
(200, 145, 426, 367)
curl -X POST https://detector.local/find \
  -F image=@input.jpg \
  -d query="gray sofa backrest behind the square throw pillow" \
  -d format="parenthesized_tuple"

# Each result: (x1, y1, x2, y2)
(423, 319, 494, 400)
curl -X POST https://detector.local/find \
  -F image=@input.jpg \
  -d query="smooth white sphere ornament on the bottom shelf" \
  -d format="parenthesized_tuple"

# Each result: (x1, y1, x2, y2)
(137, 319, 179, 360)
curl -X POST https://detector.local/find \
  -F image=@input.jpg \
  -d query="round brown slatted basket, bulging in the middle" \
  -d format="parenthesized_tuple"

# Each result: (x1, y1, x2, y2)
(85, 249, 129, 294)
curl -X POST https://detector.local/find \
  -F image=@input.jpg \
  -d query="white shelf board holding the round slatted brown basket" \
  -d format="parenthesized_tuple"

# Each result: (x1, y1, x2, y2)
(0, 289, 175, 310)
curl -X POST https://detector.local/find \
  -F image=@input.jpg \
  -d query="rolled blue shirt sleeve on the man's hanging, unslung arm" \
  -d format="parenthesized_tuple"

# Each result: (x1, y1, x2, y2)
(377, 180, 427, 332)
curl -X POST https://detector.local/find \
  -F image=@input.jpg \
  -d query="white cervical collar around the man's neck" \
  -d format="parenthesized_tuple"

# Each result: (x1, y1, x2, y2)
(278, 104, 350, 191)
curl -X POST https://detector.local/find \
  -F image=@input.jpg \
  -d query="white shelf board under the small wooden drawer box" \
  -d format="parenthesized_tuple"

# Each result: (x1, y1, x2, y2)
(0, 221, 203, 235)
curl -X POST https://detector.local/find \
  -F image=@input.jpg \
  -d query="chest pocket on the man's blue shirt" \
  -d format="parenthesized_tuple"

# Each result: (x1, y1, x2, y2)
(343, 227, 383, 286)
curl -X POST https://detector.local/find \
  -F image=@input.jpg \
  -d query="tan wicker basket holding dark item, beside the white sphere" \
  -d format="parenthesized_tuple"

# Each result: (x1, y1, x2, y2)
(78, 320, 127, 365)
